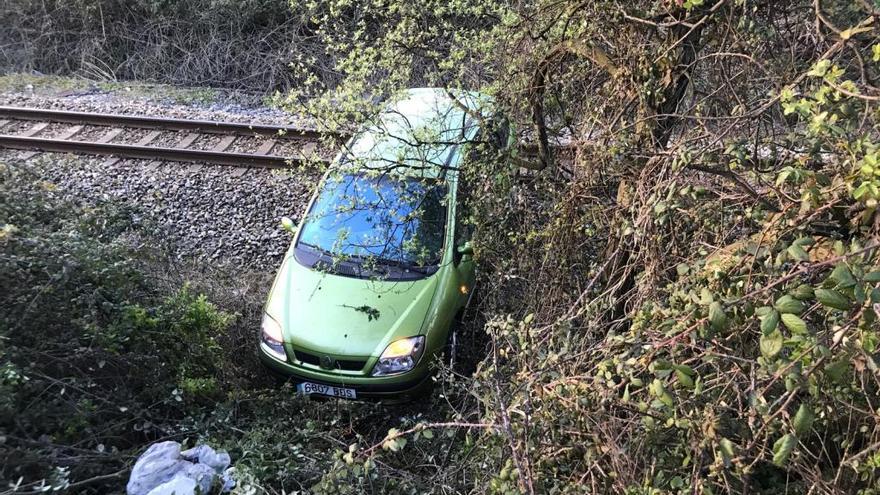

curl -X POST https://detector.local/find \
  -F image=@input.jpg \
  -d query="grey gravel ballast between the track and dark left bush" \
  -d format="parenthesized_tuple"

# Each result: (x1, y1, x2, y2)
(0, 151, 320, 270)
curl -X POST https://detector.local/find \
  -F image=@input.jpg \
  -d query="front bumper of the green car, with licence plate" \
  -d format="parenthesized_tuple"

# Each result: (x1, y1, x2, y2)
(259, 346, 431, 398)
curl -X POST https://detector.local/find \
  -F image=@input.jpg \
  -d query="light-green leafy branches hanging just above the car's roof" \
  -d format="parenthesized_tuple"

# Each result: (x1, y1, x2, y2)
(276, 0, 508, 131)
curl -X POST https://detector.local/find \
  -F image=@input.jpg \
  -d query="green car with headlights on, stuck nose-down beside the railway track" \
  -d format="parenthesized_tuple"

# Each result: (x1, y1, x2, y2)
(259, 88, 510, 399)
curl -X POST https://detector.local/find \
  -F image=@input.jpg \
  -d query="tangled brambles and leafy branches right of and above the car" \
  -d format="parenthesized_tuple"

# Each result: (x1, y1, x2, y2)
(284, 1, 880, 493)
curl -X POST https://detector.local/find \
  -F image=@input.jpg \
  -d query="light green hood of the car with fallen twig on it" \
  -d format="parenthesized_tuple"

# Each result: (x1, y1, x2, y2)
(266, 251, 438, 357)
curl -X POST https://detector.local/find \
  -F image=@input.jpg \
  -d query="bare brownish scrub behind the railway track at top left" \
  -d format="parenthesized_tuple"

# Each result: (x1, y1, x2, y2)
(0, 0, 326, 94)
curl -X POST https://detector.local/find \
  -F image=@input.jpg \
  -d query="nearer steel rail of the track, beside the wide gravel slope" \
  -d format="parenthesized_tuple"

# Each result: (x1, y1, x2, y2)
(0, 135, 304, 168)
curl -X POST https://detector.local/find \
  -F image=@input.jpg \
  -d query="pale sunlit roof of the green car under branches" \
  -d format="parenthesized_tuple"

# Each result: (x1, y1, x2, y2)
(340, 88, 494, 178)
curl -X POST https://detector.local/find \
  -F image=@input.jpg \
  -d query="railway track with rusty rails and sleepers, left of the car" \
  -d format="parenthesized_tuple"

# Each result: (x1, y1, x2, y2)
(0, 106, 336, 168)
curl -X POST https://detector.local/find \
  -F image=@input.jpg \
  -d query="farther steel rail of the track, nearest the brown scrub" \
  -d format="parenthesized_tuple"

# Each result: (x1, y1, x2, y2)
(0, 106, 340, 139)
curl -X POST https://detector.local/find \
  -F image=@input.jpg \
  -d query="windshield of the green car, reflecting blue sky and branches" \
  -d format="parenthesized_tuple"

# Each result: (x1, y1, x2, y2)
(296, 174, 446, 268)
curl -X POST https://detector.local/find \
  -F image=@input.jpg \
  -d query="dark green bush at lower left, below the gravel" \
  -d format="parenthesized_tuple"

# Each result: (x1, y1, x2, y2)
(0, 161, 239, 486)
